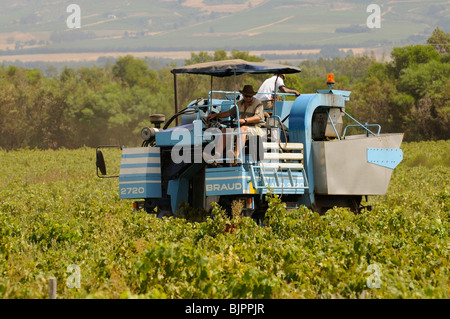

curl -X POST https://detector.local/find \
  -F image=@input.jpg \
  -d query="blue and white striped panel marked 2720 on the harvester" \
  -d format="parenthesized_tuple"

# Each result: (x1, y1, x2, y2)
(119, 147, 162, 199)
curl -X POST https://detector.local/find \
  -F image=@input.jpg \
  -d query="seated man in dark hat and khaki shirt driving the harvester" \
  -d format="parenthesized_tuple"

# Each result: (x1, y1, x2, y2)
(206, 85, 266, 165)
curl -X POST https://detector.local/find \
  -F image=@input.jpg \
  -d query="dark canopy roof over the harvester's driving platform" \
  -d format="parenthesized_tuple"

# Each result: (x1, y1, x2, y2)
(171, 59, 301, 77)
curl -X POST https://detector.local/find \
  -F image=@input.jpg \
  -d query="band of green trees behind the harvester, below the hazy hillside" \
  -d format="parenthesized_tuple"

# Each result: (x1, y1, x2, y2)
(0, 28, 450, 150)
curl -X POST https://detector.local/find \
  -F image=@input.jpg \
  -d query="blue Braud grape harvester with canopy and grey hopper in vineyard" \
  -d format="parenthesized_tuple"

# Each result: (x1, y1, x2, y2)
(96, 60, 403, 219)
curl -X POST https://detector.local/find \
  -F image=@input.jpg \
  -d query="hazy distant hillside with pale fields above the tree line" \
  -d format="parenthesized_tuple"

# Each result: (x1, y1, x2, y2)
(0, 0, 450, 59)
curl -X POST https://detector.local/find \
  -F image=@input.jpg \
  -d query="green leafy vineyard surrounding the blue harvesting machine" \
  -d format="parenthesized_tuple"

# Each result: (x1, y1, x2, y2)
(0, 140, 450, 299)
